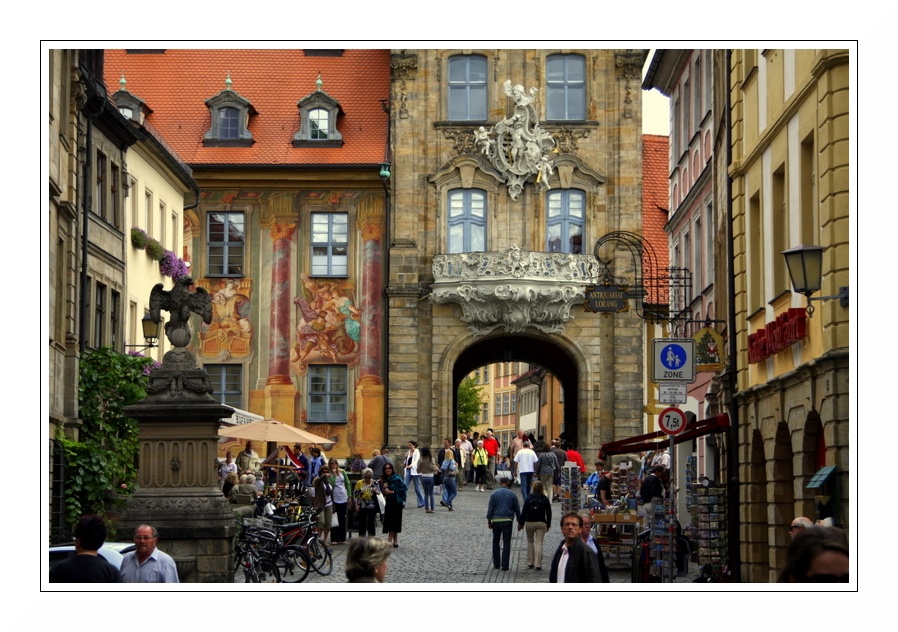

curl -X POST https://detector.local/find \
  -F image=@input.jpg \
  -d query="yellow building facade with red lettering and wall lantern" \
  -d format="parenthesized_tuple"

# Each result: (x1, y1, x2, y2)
(715, 49, 852, 582)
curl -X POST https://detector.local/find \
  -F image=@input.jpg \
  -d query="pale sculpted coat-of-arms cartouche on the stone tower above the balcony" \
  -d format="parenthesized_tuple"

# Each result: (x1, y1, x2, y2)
(474, 80, 555, 200)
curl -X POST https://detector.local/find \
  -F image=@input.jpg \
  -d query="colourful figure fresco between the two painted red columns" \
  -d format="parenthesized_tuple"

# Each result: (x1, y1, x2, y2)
(290, 273, 362, 375)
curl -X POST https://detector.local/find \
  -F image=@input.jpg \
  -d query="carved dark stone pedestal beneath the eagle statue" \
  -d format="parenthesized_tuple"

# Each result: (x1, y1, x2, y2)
(120, 350, 242, 583)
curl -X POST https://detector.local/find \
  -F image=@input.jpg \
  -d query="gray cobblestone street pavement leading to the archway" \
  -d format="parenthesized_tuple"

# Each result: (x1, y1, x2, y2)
(303, 485, 698, 588)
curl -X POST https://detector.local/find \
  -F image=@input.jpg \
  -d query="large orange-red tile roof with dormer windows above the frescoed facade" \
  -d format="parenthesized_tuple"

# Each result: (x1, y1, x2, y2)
(105, 49, 390, 167)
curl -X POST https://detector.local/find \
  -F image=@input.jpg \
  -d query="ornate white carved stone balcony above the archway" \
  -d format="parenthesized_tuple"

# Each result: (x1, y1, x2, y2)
(431, 246, 601, 336)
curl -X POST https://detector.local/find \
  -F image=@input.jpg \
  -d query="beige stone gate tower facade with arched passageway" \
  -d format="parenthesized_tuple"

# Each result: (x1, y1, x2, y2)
(387, 50, 645, 452)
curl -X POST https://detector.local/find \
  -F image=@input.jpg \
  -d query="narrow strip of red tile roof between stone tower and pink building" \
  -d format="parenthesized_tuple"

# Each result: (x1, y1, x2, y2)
(642, 134, 670, 303)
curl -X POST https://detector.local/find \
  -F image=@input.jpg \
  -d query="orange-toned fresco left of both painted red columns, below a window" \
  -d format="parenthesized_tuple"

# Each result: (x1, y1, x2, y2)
(199, 279, 253, 360)
